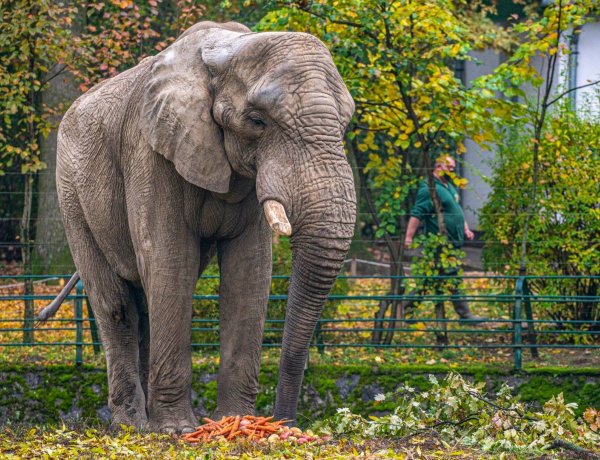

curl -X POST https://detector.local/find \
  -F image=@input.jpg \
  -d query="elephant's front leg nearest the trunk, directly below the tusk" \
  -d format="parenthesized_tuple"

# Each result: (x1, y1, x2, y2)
(214, 210, 272, 417)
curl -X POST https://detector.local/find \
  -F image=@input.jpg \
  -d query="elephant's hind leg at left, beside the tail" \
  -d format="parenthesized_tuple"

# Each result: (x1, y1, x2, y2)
(63, 189, 148, 428)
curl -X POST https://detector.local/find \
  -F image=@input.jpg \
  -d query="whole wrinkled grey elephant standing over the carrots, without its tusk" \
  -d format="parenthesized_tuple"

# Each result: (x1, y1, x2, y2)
(57, 23, 356, 432)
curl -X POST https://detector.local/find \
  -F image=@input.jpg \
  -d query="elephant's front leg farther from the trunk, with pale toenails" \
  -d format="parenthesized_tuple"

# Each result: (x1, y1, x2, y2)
(144, 243, 199, 433)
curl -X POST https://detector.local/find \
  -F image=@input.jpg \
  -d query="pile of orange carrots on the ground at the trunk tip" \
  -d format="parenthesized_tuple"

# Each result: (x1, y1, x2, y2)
(182, 415, 287, 443)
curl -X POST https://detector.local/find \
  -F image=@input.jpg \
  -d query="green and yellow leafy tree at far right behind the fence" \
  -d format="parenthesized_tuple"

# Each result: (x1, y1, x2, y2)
(481, 0, 600, 328)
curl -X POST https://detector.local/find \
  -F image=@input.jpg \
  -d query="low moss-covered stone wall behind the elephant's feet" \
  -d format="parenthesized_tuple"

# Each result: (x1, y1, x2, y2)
(0, 364, 600, 424)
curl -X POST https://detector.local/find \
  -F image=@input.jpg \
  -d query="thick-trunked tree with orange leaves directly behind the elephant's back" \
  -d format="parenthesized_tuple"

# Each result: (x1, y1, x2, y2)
(34, 0, 209, 273)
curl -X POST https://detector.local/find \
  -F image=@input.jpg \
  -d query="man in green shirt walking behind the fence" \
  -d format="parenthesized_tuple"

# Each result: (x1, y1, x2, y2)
(404, 156, 485, 324)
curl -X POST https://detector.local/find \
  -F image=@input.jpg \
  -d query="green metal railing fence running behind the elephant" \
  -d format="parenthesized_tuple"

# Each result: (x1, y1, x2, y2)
(0, 275, 600, 370)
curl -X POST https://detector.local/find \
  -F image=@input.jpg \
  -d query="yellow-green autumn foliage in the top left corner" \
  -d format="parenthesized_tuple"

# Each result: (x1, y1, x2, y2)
(0, 0, 72, 175)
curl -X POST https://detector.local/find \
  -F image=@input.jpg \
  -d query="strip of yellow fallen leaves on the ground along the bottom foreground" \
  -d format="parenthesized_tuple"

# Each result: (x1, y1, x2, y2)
(0, 426, 580, 460)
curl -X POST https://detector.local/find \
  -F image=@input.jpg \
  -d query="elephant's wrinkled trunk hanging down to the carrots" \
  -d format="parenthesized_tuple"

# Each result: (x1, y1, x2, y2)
(275, 161, 356, 423)
